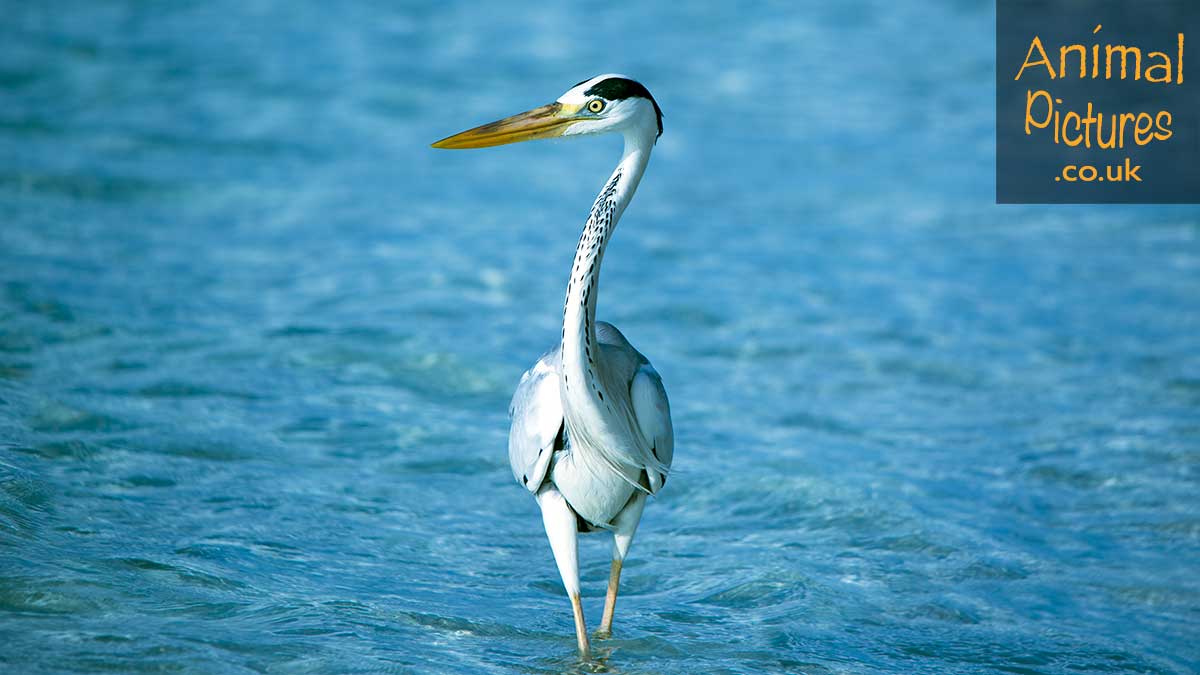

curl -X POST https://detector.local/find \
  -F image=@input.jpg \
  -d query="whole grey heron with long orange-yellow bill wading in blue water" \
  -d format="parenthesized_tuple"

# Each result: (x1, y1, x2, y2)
(433, 74, 674, 657)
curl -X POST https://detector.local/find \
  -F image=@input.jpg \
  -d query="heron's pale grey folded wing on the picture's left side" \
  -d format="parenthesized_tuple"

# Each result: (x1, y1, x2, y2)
(509, 350, 563, 492)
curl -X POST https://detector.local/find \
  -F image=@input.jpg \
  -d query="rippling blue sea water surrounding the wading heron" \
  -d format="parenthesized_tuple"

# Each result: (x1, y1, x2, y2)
(0, 0, 1200, 674)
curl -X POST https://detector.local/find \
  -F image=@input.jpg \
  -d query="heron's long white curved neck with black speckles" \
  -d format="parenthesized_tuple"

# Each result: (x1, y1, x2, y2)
(560, 130, 655, 434)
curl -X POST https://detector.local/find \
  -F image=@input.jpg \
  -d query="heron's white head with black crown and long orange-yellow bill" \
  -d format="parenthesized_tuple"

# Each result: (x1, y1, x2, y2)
(433, 74, 662, 150)
